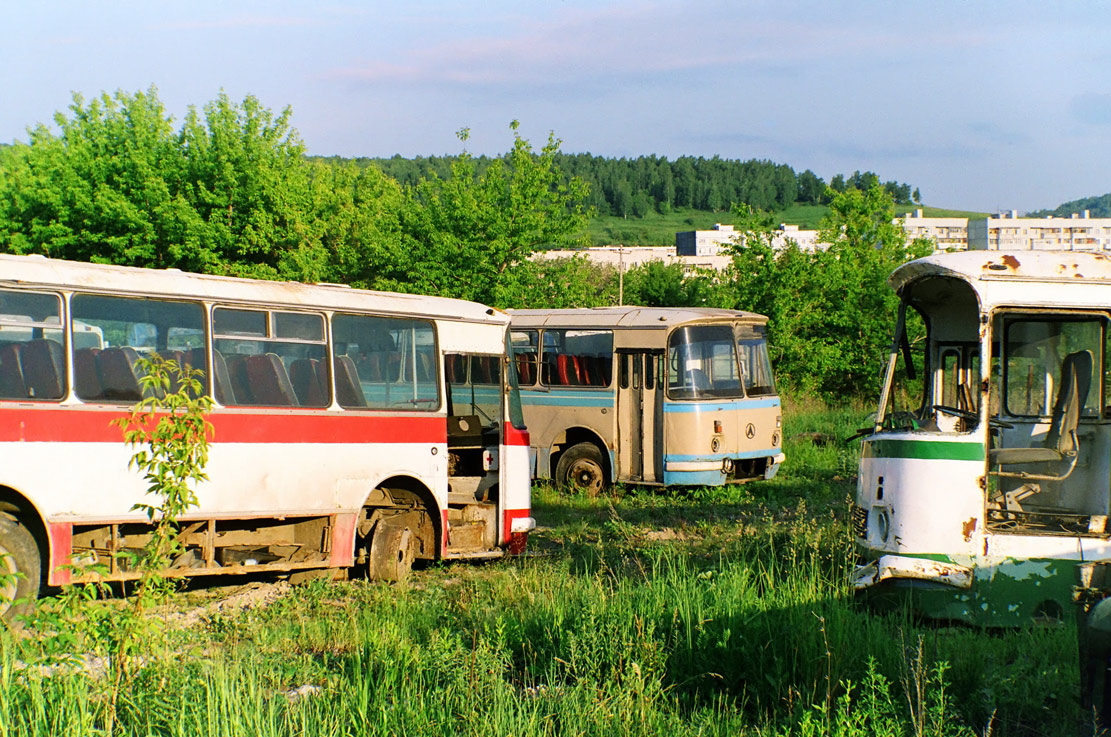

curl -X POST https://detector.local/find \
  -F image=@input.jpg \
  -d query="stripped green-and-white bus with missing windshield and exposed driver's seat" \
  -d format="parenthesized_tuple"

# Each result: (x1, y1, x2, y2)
(853, 251, 1111, 626)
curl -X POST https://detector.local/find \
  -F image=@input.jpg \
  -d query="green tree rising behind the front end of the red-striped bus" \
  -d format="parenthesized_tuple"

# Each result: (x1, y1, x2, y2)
(373, 121, 589, 306)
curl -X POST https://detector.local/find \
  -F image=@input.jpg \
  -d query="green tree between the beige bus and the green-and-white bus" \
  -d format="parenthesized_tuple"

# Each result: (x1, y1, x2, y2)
(732, 182, 931, 397)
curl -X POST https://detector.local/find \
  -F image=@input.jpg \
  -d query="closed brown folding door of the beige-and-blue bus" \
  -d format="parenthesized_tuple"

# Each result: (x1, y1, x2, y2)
(618, 351, 663, 482)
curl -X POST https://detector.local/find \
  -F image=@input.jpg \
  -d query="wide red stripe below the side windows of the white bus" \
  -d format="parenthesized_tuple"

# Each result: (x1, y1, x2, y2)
(0, 408, 448, 444)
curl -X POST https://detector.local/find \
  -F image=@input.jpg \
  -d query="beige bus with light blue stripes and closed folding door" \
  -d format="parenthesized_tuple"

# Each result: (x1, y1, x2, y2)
(510, 307, 783, 494)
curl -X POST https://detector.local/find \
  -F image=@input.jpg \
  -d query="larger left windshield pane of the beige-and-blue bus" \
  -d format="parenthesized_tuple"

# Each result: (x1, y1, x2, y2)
(668, 325, 744, 399)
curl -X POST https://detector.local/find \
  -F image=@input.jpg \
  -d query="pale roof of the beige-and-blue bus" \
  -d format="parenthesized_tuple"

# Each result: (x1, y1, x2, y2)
(509, 306, 768, 330)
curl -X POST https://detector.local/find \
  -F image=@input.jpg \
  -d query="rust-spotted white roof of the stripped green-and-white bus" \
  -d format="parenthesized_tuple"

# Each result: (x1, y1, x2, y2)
(888, 250, 1111, 310)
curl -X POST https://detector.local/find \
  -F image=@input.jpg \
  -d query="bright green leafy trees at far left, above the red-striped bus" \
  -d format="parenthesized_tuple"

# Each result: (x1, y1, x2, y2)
(0, 88, 400, 280)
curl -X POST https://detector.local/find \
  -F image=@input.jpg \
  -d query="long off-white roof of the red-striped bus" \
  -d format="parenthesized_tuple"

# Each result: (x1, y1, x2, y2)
(0, 253, 509, 325)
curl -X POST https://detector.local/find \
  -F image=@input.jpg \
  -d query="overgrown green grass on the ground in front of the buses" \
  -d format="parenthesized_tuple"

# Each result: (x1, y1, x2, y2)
(0, 404, 1083, 737)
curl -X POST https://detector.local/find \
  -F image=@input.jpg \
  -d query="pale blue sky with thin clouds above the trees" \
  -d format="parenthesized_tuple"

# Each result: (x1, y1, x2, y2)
(0, 0, 1111, 212)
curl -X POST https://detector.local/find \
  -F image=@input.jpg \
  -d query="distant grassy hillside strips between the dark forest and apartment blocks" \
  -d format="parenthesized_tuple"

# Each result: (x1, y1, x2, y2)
(589, 205, 985, 246)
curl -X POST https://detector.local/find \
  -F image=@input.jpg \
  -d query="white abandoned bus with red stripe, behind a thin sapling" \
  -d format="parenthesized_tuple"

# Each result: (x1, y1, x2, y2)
(0, 256, 534, 618)
